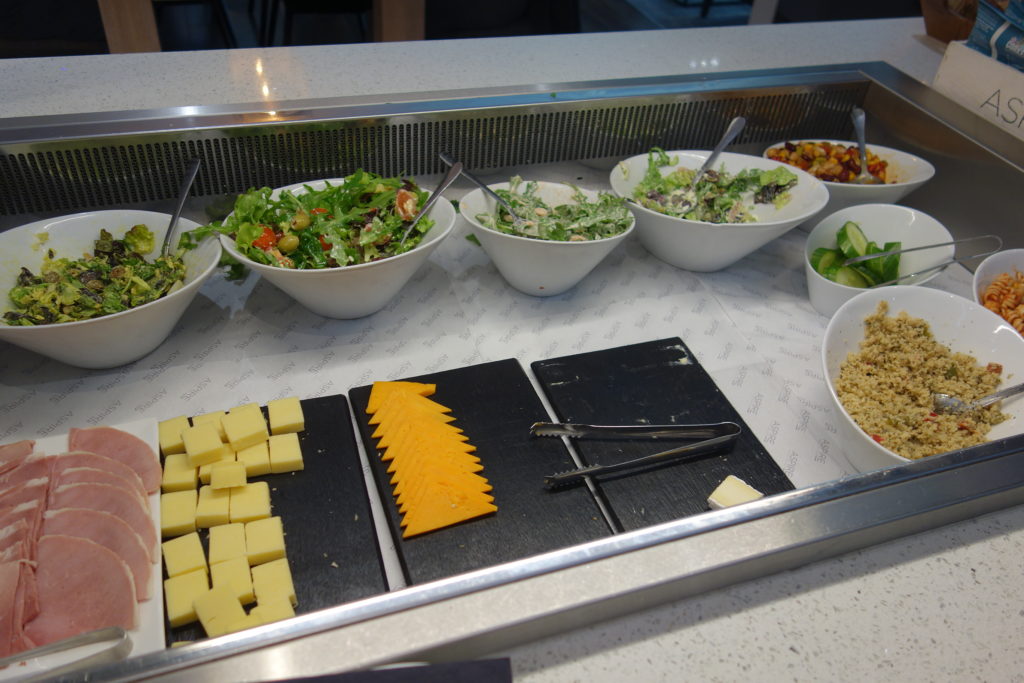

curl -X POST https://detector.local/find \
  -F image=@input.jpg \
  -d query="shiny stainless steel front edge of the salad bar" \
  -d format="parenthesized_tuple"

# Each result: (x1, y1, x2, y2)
(72, 436, 1024, 681)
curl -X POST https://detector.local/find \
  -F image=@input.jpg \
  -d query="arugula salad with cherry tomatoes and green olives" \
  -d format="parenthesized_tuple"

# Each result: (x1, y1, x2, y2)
(209, 170, 434, 269)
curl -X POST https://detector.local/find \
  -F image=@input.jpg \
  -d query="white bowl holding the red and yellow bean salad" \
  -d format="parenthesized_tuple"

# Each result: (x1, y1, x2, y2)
(763, 139, 935, 216)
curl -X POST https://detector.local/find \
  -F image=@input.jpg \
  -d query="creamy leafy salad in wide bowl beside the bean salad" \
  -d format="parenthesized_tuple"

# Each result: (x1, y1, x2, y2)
(633, 147, 797, 223)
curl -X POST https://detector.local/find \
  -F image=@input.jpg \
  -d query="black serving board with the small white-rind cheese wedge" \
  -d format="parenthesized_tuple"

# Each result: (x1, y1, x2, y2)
(530, 338, 794, 531)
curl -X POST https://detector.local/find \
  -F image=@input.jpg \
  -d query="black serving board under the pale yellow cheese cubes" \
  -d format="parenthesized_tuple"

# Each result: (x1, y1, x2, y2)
(164, 395, 387, 645)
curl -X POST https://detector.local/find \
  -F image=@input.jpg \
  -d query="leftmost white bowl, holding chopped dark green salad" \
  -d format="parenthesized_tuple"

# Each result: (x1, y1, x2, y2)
(0, 210, 220, 369)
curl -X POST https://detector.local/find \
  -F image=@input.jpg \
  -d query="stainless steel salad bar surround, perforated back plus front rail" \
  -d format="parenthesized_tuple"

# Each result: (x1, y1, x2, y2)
(6, 62, 1024, 680)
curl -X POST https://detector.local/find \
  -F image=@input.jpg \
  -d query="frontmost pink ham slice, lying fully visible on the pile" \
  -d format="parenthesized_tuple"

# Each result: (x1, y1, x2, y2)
(25, 535, 136, 646)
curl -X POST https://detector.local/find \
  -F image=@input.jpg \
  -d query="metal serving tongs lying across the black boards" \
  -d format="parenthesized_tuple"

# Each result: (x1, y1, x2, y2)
(529, 422, 742, 488)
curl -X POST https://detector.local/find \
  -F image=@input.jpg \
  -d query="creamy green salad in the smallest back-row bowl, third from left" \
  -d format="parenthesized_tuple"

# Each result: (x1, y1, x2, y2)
(476, 176, 633, 242)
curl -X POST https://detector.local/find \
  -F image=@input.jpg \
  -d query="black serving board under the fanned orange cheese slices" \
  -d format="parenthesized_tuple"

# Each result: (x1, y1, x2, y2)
(349, 359, 610, 584)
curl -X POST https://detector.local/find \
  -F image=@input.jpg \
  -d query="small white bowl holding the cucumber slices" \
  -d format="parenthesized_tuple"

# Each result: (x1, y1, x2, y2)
(804, 204, 954, 316)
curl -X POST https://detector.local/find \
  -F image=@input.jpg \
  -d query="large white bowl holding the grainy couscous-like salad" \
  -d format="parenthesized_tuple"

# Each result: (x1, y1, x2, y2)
(821, 285, 1024, 472)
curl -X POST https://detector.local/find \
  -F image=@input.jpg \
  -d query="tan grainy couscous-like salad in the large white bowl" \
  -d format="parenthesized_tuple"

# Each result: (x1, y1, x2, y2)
(836, 301, 1008, 459)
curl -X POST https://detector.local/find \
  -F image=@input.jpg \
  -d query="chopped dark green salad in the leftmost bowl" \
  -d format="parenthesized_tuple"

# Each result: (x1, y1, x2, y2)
(3, 225, 185, 326)
